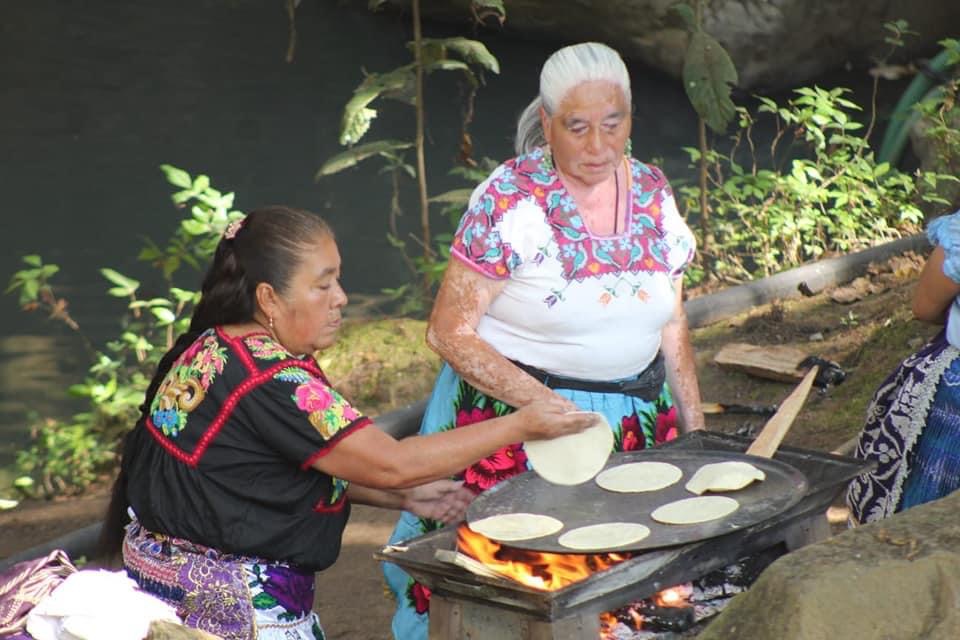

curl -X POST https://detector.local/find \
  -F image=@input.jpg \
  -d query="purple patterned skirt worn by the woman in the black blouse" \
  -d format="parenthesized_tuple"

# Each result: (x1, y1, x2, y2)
(123, 519, 324, 640)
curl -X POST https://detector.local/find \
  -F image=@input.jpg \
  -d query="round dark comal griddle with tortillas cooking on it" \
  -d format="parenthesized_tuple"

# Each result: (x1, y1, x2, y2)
(467, 449, 807, 553)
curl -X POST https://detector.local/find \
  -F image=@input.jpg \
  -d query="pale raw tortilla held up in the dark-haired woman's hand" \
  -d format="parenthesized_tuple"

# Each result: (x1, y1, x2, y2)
(523, 411, 613, 485)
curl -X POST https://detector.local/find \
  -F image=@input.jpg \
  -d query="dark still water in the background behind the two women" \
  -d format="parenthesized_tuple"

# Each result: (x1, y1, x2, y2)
(0, 0, 912, 480)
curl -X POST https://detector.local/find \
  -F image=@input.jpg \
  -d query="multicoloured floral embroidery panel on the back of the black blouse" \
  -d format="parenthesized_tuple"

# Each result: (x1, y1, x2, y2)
(150, 331, 227, 438)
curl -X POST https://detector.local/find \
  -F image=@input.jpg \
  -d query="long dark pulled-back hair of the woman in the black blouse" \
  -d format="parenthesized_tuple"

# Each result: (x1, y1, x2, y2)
(100, 206, 333, 556)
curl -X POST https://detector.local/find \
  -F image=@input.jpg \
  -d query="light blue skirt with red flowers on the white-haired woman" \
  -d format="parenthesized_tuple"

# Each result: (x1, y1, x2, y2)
(383, 365, 677, 640)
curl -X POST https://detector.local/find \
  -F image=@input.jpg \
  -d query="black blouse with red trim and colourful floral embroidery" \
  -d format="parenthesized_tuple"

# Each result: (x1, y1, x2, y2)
(124, 328, 371, 571)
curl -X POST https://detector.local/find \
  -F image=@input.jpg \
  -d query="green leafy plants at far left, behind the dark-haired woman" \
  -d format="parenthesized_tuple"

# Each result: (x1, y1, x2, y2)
(7, 165, 243, 496)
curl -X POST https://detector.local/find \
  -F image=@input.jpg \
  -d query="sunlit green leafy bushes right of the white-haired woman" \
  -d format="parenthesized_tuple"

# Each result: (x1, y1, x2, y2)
(680, 87, 951, 281)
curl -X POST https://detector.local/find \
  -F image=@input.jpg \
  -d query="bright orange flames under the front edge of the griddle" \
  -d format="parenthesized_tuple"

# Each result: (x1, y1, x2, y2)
(457, 525, 630, 591)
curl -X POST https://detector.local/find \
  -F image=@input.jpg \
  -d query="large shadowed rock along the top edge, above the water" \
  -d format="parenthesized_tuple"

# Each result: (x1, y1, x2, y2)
(388, 0, 960, 89)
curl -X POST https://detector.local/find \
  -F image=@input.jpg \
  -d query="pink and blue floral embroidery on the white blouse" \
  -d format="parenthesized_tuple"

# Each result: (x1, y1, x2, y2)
(452, 149, 693, 307)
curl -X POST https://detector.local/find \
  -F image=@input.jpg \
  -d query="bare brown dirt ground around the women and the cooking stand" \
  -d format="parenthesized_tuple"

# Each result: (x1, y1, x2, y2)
(0, 250, 935, 640)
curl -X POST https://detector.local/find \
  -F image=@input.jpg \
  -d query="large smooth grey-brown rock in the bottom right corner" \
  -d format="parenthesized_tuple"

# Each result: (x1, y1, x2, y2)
(698, 492, 960, 640)
